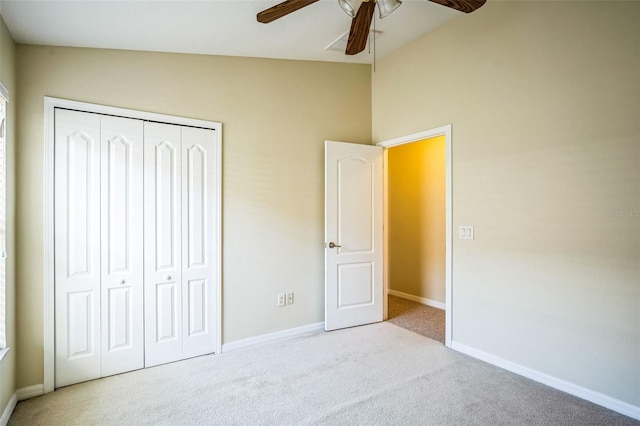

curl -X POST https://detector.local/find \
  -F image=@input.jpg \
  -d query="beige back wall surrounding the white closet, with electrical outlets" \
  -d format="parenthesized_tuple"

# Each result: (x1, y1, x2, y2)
(18, 45, 371, 387)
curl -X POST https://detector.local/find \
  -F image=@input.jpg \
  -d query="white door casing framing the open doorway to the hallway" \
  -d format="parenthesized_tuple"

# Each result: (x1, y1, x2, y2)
(376, 124, 453, 347)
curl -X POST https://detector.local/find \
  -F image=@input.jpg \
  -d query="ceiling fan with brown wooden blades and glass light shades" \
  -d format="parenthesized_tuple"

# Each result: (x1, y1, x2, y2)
(257, 0, 486, 55)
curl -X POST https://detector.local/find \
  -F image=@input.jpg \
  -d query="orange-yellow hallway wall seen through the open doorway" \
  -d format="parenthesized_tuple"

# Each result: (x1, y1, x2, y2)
(387, 136, 447, 304)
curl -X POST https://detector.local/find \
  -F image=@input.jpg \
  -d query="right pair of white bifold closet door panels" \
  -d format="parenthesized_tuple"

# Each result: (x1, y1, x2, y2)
(144, 122, 217, 367)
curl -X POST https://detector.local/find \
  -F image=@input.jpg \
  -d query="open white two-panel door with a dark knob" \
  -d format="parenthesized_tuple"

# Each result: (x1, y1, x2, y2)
(325, 141, 384, 331)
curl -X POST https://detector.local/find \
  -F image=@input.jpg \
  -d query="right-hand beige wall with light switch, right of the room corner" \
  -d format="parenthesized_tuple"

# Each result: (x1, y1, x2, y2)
(372, 1, 640, 407)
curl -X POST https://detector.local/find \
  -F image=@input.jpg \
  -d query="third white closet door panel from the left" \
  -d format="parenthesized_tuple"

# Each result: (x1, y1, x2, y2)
(144, 122, 182, 367)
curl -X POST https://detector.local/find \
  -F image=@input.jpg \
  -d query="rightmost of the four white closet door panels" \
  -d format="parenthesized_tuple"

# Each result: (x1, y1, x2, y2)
(182, 127, 218, 358)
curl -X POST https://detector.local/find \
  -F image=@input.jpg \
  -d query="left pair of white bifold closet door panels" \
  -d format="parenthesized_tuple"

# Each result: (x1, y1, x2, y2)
(54, 110, 144, 387)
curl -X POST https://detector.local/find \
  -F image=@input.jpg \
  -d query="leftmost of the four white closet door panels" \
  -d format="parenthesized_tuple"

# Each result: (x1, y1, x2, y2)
(54, 110, 101, 387)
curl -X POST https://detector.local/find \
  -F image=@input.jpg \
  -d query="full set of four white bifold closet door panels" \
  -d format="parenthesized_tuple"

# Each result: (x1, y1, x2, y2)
(51, 102, 220, 387)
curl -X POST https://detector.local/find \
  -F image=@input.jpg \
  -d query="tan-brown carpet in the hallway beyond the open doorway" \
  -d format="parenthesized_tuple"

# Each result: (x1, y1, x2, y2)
(387, 295, 445, 343)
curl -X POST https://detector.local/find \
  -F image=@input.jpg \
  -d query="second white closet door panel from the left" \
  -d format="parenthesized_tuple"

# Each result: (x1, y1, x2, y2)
(101, 116, 144, 376)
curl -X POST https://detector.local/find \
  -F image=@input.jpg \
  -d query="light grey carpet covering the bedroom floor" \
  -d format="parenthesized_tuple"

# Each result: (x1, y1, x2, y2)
(9, 322, 640, 426)
